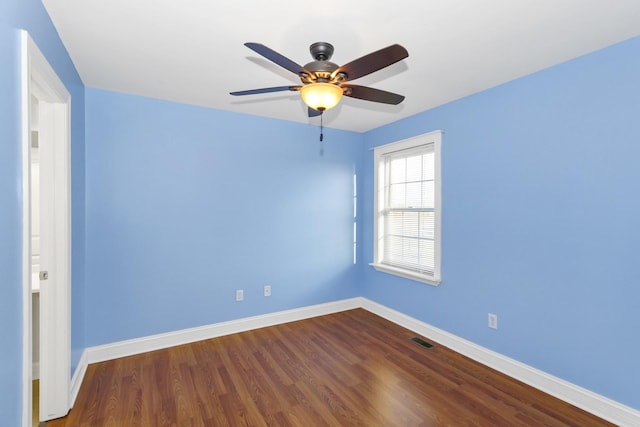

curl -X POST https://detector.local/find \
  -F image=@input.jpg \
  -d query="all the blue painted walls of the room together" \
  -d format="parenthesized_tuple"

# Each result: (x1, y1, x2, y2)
(0, 0, 640, 425)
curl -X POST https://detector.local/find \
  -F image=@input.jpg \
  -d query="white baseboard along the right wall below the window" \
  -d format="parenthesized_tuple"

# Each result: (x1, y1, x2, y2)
(362, 298, 640, 427)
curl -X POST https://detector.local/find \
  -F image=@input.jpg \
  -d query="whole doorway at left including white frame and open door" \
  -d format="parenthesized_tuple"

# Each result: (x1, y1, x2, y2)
(21, 31, 71, 427)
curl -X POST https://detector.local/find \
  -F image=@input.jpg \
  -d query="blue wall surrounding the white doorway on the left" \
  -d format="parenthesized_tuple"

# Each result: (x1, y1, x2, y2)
(0, 0, 84, 426)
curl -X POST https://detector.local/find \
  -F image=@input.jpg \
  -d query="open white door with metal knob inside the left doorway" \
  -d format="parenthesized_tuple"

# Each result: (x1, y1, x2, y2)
(38, 99, 71, 421)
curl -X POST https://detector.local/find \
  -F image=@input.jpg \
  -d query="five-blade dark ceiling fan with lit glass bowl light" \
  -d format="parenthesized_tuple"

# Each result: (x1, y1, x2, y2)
(231, 42, 409, 117)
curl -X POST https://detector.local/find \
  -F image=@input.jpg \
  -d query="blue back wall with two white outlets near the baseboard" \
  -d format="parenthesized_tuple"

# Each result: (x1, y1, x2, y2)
(86, 89, 362, 345)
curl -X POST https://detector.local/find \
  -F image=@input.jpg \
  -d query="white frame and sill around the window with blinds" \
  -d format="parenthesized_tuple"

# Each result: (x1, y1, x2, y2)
(370, 131, 442, 286)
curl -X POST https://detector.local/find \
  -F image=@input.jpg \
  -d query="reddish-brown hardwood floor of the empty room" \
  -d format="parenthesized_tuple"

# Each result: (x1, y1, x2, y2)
(47, 309, 612, 427)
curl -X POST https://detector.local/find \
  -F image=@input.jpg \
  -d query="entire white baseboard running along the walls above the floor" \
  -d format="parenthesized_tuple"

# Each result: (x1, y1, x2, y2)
(71, 297, 640, 426)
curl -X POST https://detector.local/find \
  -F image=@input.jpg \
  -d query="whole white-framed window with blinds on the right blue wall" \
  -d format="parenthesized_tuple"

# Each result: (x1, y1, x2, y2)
(371, 131, 442, 285)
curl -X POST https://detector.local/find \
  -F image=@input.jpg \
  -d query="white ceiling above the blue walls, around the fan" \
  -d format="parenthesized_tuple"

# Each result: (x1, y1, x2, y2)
(42, 0, 640, 132)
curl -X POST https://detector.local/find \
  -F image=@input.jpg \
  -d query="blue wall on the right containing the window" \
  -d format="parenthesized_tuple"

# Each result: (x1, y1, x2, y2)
(362, 38, 640, 409)
